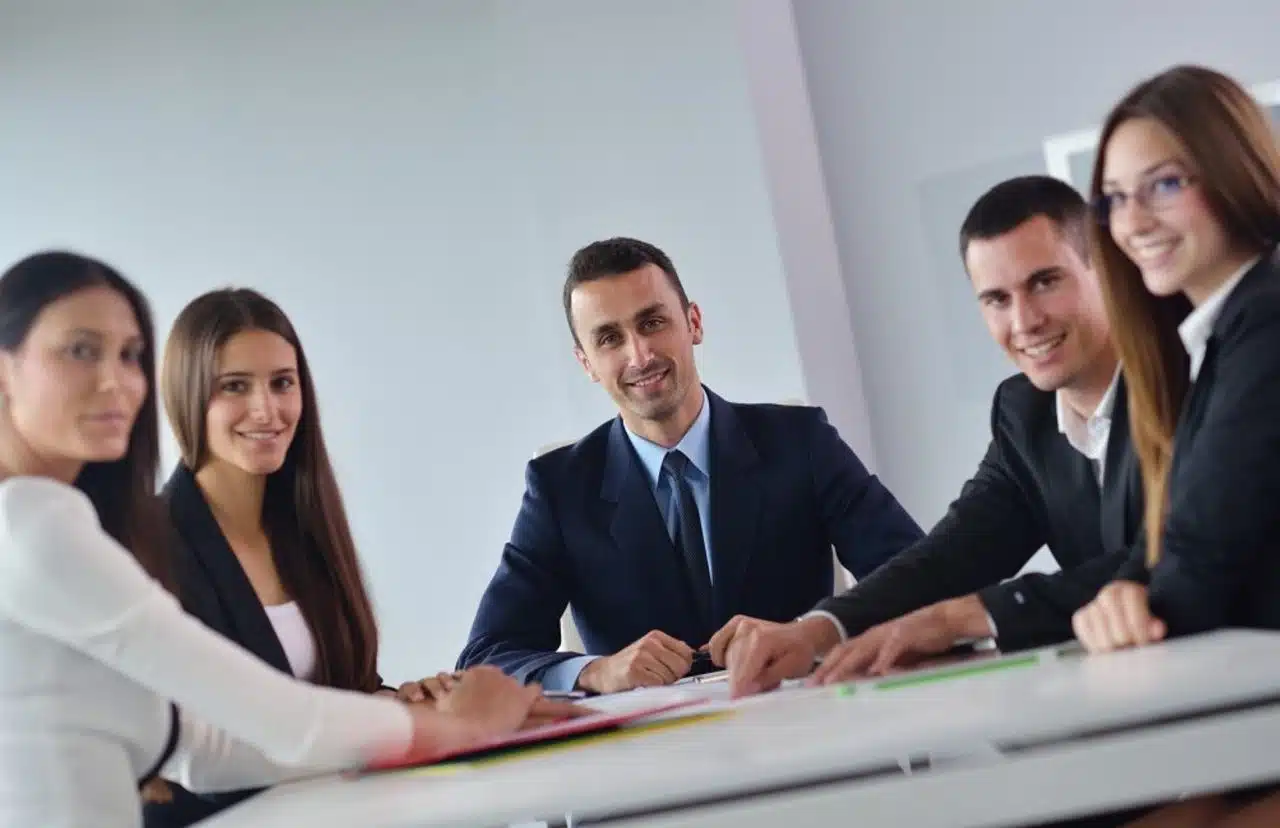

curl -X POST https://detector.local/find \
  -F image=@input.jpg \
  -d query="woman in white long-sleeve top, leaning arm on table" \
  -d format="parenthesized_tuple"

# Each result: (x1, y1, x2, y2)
(0, 253, 571, 828)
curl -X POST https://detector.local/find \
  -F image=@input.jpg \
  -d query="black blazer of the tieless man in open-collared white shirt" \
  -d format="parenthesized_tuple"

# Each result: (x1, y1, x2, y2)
(818, 374, 1142, 651)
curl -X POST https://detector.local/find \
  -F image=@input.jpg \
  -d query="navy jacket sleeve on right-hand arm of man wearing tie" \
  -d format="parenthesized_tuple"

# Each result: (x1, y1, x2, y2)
(809, 408, 924, 580)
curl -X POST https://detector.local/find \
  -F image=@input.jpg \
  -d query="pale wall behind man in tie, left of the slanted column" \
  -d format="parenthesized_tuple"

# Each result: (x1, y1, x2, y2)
(0, 0, 808, 680)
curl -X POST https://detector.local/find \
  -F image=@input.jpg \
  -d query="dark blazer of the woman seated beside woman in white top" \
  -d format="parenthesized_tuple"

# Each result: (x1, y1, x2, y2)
(143, 465, 384, 828)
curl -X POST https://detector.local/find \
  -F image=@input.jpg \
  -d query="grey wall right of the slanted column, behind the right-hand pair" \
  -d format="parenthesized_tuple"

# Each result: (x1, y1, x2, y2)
(794, 0, 1280, 537)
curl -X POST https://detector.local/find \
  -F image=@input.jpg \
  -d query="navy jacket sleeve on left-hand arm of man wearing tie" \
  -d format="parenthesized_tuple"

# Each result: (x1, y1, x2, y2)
(457, 463, 581, 682)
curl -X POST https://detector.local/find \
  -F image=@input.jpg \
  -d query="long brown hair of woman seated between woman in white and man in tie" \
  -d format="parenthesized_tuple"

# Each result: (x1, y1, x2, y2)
(161, 288, 379, 692)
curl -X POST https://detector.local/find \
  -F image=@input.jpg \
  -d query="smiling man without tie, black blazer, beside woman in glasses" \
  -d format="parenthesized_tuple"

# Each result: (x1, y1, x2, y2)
(709, 175, 1142, 695)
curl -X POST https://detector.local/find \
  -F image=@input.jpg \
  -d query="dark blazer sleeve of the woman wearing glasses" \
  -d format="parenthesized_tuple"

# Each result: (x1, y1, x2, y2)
(1148, 304, 1280, 635)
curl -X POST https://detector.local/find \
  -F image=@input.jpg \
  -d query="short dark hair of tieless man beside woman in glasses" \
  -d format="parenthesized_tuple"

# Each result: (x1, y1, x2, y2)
(960, 175, 1089, 261)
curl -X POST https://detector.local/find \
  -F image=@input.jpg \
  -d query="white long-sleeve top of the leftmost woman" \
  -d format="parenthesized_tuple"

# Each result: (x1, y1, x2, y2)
(0, 477, 412, 828)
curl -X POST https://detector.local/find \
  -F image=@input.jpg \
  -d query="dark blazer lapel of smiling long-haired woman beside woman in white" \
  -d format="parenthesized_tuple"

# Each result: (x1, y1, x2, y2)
(165, 466, 293, 673)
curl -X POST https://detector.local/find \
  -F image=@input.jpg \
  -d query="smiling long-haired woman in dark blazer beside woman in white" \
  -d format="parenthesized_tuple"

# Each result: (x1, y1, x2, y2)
(146, 288, 448, 828)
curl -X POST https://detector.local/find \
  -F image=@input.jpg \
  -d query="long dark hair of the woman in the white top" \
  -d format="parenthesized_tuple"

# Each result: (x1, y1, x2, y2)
(0, 251, 174, 590)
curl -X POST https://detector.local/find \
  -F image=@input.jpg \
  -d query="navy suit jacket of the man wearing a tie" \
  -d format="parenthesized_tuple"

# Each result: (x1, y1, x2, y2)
(458, 392, 922, 681)
